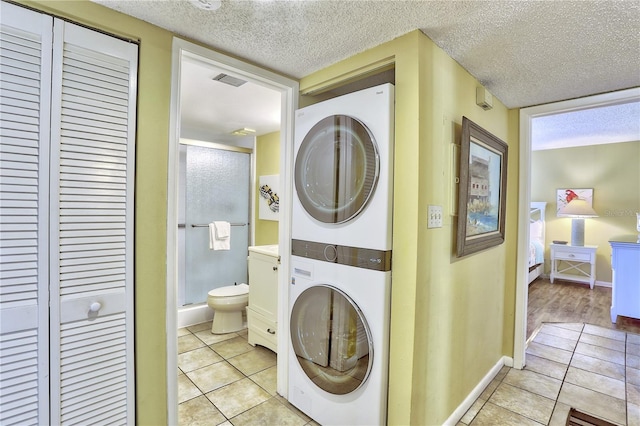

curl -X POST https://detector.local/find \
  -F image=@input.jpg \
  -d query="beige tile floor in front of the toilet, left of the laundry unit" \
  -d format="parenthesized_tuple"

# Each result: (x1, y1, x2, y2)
(178, 322, 317, 426)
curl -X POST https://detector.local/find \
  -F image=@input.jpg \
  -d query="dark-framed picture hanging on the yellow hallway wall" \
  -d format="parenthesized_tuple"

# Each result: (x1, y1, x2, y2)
(456, 117, 509, 257)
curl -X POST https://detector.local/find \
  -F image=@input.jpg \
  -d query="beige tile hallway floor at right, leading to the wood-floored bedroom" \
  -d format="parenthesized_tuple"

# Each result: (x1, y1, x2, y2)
(460, 323, 640, 426)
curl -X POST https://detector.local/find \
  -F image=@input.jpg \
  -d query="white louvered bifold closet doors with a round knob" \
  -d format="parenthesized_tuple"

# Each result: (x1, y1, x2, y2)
(0, 2, 138, 425)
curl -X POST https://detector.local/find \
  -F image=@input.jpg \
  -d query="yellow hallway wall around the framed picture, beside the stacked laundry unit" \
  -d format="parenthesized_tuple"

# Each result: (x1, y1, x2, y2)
(300, 31, 518, 425)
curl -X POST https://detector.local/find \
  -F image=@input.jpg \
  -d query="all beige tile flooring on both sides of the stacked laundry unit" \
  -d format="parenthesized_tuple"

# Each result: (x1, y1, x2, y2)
(178, 322, 640, 426)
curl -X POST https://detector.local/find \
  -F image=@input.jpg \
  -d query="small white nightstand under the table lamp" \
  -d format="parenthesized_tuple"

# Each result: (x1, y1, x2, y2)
(550, 244, 598, 289)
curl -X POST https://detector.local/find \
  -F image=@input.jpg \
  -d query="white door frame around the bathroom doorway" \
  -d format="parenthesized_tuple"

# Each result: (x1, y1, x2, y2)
(165, 37, 300, 424)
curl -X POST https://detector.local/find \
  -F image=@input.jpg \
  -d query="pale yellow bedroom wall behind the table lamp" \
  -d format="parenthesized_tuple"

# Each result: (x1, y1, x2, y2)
(531, 142, 640, 283)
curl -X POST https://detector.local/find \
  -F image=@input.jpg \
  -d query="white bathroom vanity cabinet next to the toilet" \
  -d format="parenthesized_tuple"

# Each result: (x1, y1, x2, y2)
(247, 246, 280, 353)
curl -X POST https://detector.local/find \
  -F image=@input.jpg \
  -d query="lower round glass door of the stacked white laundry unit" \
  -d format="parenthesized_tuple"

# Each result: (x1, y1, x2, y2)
(290, 285, 373, 395)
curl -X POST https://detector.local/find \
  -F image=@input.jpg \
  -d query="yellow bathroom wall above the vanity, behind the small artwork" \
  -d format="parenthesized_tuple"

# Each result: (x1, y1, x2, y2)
(253, 132, 280, 246)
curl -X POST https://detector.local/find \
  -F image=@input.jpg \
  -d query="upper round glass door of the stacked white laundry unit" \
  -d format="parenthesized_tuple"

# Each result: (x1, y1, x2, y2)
(295, 115, 380, 223)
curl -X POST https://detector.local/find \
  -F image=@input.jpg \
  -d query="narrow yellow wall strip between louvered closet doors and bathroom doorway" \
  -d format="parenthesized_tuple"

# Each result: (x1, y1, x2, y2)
(21, 0, 173, 425)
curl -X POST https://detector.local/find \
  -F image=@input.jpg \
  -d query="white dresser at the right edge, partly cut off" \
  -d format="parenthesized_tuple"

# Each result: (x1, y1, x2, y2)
(609, 235, 640, 323)
